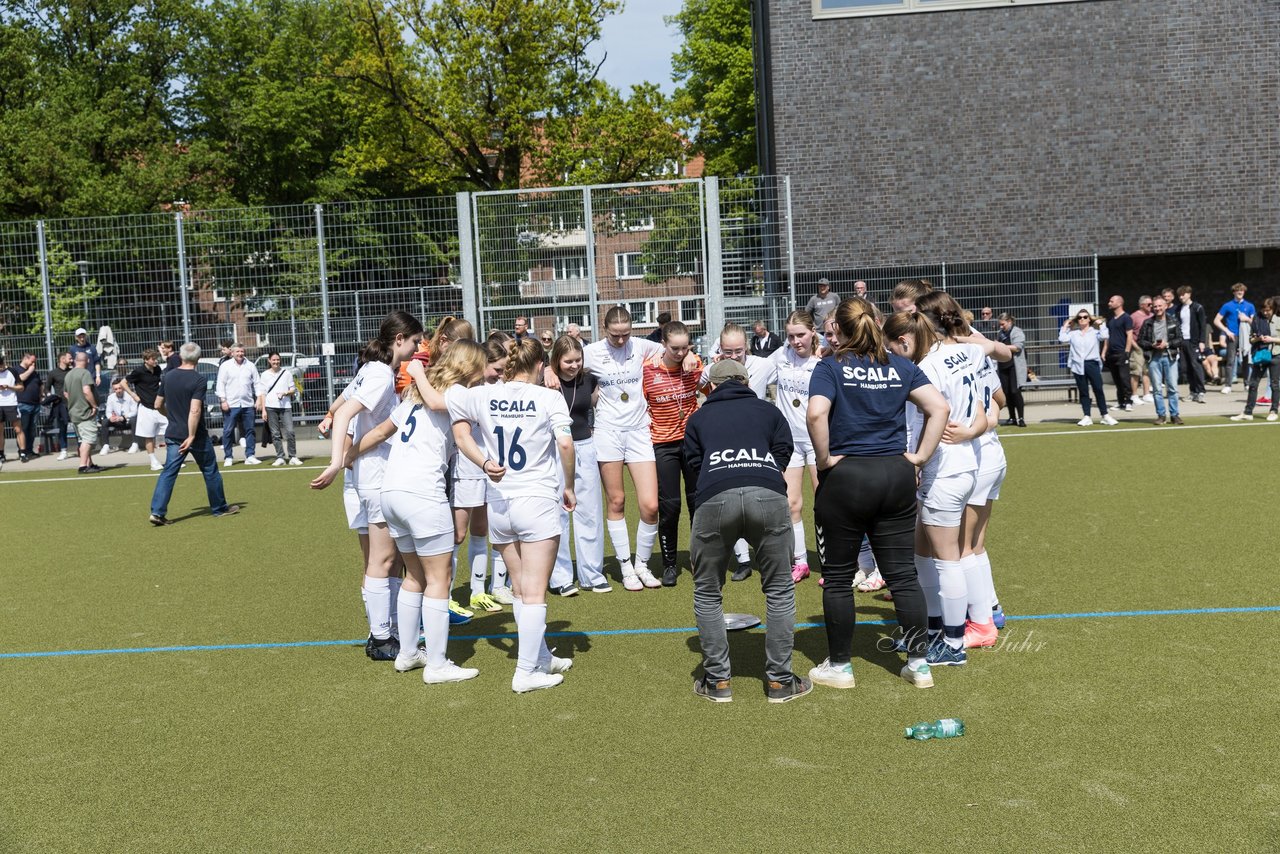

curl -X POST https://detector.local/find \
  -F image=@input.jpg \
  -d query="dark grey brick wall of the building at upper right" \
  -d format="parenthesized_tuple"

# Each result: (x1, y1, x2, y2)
(763, 0, 1280, 267)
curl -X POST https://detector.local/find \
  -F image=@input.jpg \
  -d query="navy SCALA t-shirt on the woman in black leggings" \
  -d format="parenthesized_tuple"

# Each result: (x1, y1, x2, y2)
(809, 353, 929, 457)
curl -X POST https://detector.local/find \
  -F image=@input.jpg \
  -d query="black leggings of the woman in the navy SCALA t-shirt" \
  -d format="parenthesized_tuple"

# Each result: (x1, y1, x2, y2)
(813, 455, 928, 665)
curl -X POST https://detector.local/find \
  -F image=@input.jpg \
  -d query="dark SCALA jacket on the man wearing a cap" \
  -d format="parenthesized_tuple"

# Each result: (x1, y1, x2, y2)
(684, 380, 794, 508)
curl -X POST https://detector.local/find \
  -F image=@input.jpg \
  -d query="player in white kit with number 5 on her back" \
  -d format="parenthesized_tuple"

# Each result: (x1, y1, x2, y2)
(348, 341, 485, 685)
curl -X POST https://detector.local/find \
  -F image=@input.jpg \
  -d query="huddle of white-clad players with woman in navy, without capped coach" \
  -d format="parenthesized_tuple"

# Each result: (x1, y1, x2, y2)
(311, 280, 1012, 693)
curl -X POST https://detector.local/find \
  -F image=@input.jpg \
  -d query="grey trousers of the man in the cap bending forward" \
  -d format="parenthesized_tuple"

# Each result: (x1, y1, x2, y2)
(689, 487, 796, 681)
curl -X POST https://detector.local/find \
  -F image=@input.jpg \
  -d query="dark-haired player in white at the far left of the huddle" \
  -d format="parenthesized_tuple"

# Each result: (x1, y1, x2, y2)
(311, 311, 422, 661)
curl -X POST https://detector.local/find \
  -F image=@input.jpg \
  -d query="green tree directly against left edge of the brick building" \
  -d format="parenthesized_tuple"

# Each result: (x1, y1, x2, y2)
(668, 0, 758, 175)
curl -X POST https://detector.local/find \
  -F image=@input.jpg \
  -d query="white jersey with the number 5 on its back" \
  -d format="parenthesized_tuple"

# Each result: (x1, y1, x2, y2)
(383, 401, 453, 504)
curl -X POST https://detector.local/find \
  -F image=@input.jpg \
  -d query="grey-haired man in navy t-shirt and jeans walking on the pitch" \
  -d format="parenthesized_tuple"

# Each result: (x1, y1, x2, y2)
(150, 342, 239, 528)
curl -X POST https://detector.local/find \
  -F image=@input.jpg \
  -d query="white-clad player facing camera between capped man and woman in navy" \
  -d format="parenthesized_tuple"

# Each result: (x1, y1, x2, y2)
(768, 311, 822, 584)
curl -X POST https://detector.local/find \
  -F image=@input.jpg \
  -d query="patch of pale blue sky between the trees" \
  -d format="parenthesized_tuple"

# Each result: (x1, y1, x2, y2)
(596, 0, 682, 95)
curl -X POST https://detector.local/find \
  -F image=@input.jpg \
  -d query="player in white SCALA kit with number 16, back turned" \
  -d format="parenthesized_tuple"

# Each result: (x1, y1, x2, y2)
(448, 338, 577, 694)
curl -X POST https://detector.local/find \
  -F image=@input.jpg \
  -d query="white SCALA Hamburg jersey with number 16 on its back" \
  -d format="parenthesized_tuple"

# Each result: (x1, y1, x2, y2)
(445, 382, 572, 501)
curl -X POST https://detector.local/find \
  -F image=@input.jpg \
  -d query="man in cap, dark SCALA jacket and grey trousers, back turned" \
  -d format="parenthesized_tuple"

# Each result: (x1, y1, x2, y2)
(685, 359, 813, 703)
